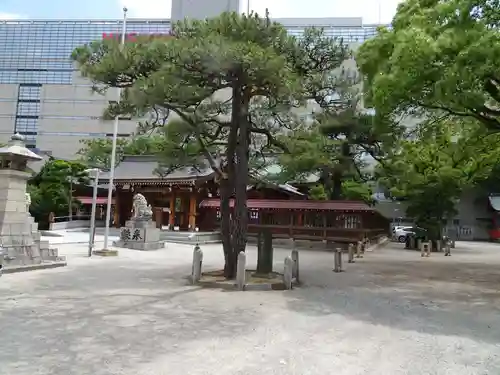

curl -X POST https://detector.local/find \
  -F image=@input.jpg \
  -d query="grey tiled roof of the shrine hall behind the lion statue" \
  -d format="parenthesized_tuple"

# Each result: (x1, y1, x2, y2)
(100, 156, 213, 180)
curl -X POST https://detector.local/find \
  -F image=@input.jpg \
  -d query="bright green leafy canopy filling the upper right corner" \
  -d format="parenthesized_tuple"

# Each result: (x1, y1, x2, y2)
(356, 0, 500, 131)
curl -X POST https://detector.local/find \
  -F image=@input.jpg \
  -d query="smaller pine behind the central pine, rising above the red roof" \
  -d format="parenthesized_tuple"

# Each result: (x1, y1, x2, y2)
(280, 98, 400, 203)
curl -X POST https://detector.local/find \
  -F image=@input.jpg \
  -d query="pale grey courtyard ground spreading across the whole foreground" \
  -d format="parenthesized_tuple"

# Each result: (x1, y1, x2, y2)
(0, 243, 500, 375)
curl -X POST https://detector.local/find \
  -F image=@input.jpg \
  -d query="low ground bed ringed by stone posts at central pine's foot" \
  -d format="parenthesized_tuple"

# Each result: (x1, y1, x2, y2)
(190, 270, 298, 291)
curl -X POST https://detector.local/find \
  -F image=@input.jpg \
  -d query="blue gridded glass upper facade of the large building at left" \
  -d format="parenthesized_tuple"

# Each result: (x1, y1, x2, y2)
(0, 20, 170, 84)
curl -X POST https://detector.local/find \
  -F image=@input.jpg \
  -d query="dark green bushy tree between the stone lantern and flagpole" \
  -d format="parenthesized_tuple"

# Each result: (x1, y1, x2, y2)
(27, 160, 88, 227)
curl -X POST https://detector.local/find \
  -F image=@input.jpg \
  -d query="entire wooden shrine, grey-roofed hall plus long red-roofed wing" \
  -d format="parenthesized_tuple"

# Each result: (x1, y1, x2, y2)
(95, 156, 389, 243)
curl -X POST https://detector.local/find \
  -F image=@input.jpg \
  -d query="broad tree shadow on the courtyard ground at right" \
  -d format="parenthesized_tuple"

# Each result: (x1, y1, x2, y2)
(287, 248, 500, 344)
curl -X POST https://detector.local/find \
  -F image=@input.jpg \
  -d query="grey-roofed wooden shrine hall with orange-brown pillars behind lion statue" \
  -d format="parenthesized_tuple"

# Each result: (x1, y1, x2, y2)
(99, 156, 305, 231)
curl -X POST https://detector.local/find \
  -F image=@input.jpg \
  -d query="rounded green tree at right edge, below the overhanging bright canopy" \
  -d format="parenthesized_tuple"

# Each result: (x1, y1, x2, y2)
(378, 120, 500, 239)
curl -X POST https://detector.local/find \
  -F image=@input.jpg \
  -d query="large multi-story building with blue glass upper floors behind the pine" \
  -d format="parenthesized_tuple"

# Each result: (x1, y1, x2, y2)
(0, 14, 382, 158)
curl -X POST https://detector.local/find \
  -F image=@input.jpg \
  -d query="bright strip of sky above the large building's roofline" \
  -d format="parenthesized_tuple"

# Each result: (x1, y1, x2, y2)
(0, 0, 401, 23)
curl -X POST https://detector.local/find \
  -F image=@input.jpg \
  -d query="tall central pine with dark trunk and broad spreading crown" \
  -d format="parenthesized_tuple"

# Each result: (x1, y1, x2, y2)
(73, 13, 352, 278)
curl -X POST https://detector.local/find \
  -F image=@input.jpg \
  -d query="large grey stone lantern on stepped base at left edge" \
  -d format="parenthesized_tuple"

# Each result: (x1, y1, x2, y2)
(0, 134, 66, 272)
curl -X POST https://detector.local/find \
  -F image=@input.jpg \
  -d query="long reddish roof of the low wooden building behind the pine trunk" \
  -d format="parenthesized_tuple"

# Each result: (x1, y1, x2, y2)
(200, 198, 375, 212)
